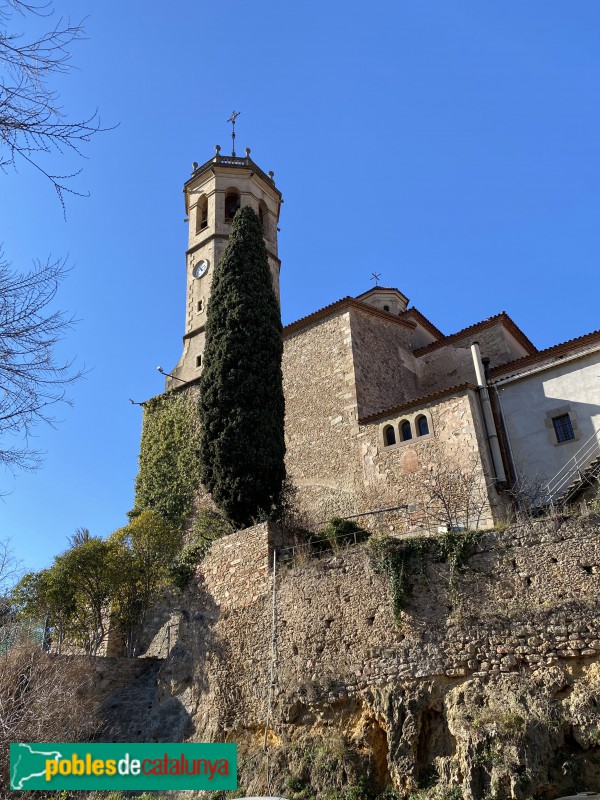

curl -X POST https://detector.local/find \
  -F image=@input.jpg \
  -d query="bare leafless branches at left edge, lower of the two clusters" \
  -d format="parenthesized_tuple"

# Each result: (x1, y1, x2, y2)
(0, 254, 81, 469)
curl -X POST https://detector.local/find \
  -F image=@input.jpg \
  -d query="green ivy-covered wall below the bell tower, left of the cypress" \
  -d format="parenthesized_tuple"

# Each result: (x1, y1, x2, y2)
(134, 388, 200, 527)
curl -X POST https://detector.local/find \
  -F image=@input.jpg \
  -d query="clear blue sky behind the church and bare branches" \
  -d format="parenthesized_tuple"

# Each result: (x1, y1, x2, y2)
(0, 0, 600, 569)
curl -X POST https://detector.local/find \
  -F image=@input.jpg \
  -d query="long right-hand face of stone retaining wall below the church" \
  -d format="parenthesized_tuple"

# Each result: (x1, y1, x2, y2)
(278, 521, 600, 700)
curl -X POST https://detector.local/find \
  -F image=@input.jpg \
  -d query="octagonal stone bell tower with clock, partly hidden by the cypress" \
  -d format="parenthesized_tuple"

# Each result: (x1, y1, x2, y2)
(166, 145, 283, 391)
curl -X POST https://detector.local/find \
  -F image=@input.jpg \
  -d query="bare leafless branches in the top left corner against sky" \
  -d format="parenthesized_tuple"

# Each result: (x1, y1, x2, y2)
(0, 0, 101, 209)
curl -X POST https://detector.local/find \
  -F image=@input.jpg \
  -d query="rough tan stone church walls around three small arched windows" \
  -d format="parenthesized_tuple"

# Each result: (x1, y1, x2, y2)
(284, 310, 495, 532)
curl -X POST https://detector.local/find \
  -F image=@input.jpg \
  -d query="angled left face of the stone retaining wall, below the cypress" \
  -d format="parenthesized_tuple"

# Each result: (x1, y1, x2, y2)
(161, 523, 282, 741)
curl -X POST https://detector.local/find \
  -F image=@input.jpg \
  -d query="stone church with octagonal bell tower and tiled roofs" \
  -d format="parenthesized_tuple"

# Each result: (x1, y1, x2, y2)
(166, 146, 600, 533)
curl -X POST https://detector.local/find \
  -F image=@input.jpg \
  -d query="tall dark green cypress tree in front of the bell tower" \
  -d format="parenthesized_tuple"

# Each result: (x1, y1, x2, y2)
(199, 206, 285, 525)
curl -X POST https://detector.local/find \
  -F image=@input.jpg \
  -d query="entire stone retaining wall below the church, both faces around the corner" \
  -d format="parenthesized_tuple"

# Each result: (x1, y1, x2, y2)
(163, 518, 600, 739)
